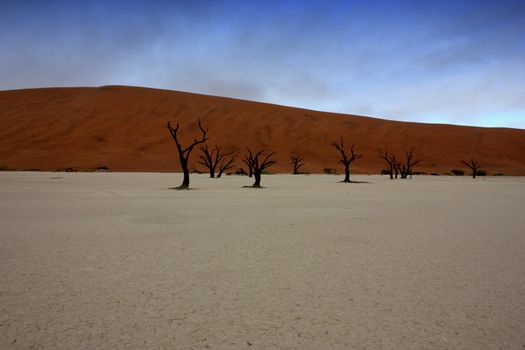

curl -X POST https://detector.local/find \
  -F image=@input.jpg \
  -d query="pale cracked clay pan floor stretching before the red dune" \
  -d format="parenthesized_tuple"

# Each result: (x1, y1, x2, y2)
(0, 172, 525, 349)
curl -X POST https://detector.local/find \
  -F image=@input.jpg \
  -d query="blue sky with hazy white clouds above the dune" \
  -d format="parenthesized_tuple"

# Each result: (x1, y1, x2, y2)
(0, 0, 525, 128)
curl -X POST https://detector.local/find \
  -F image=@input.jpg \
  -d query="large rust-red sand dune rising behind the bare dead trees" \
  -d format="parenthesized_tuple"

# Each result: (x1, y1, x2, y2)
(0, 86, 525, 175)
